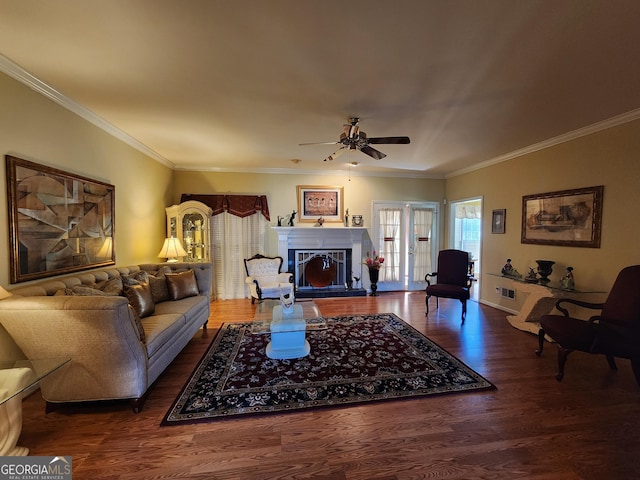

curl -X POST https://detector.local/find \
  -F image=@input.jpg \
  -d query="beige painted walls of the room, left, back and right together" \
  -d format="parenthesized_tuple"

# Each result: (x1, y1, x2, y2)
(0, 67, 640, 356)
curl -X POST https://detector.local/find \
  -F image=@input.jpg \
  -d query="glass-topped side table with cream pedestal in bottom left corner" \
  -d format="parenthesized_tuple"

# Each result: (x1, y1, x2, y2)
(0, 359, 71, 456)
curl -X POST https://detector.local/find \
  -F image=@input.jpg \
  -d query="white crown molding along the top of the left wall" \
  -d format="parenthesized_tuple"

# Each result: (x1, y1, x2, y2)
(0, 54, 175, 169)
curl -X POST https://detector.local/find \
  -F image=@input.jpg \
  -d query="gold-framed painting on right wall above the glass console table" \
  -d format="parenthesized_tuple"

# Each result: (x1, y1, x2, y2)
(521, 185, 604, 248)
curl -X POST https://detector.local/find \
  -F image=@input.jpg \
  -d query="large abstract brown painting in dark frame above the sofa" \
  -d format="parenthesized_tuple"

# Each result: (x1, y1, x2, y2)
(6, 155, 115, 283)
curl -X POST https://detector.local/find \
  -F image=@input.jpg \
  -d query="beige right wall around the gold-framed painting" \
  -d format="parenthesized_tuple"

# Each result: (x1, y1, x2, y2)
(446, 121, 640, 308)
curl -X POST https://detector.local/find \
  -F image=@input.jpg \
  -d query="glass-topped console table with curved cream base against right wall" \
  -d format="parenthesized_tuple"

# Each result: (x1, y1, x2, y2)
(487, 273, 607, 335)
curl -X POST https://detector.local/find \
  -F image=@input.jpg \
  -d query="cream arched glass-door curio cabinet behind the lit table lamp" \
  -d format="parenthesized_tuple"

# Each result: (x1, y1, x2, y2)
(166, 200, 213, 262)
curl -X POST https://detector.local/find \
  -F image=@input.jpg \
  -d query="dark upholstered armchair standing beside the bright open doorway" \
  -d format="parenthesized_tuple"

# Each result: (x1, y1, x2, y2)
(424, 249, 473, 323)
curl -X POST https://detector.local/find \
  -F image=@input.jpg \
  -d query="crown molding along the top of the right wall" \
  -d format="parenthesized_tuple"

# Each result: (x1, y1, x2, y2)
(445, 108, 640, 178)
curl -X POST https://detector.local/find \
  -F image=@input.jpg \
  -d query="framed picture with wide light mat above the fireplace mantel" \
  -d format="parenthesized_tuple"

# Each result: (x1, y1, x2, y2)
(298, 185, 344, 222)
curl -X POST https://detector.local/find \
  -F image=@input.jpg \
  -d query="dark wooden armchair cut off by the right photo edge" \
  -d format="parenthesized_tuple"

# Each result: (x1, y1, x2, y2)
(536, 265, 640, 384)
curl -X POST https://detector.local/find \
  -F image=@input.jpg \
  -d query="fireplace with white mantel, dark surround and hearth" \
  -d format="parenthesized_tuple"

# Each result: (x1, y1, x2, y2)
(272, 227, 366, 298)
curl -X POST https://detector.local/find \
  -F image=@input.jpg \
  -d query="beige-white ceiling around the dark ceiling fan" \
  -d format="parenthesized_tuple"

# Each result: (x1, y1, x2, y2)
(0, 0, 640, 177)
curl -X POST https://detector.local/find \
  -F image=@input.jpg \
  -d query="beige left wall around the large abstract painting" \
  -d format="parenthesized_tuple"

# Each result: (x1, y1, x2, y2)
(0, 74, 173, 358)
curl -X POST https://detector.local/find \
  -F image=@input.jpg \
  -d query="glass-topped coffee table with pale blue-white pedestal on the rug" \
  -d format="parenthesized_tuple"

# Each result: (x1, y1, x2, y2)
(251, 300, 327, 360)
